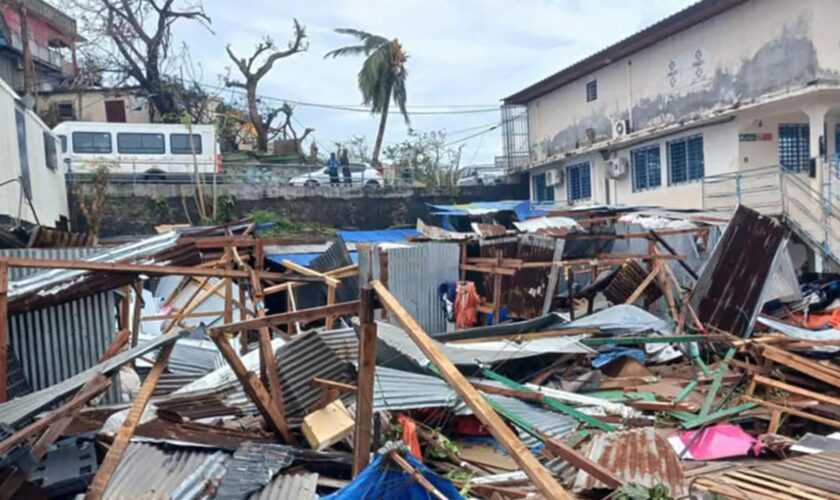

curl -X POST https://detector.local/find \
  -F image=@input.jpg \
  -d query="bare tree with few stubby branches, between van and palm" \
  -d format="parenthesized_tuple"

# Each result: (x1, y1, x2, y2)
(225, 19, 309, 152)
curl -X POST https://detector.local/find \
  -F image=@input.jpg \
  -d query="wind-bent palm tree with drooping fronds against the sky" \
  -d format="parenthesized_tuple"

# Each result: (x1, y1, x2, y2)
(324, 28, 409, 167)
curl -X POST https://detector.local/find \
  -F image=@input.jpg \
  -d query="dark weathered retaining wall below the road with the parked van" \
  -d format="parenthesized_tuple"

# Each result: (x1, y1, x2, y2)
(71, 184, 528, 236)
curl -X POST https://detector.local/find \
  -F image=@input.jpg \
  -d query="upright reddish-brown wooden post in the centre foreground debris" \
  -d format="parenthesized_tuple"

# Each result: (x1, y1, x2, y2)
(353, 285, 376, 477)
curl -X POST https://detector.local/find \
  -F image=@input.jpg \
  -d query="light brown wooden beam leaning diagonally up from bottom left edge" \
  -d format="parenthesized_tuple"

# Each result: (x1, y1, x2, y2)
(85, 342, 175, 500)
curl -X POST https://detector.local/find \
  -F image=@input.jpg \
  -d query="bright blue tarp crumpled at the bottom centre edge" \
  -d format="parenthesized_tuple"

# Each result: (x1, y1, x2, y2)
(321, 453, 464, 500)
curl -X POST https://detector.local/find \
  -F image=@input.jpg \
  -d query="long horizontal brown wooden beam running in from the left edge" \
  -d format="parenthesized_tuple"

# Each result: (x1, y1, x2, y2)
(0, 257, 298, 282)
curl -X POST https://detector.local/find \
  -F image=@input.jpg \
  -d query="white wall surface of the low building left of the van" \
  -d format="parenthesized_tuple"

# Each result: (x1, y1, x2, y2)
(0, 78, 69, 226)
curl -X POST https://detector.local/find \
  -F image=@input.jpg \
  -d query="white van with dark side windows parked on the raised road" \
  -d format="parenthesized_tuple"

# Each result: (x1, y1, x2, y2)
(53, 122, 217, 178)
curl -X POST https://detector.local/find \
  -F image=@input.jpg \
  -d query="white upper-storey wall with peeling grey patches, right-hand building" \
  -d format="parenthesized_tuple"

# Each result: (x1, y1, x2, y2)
(528, 0, 840, 162)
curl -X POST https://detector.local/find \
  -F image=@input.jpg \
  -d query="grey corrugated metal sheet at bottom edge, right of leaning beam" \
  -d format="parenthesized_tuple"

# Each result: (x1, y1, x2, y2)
(103, 442, 230, 500)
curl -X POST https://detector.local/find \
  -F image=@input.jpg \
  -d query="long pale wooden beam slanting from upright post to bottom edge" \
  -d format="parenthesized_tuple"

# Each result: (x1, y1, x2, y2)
(372, 281, 572, 499)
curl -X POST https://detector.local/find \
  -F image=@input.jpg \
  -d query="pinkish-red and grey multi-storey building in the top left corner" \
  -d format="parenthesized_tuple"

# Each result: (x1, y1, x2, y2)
(0, 0, 80, 93)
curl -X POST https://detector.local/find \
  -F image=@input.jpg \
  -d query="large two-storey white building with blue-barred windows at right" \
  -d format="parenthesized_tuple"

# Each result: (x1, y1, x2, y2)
(504, 0, 840, 208)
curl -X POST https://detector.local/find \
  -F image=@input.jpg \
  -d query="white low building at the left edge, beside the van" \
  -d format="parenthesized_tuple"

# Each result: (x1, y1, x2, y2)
(0, 80, 69, 227)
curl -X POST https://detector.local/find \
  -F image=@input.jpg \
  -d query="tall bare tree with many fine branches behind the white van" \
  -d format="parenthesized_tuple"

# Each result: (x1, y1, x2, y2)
(74, 0, 211, 115)
